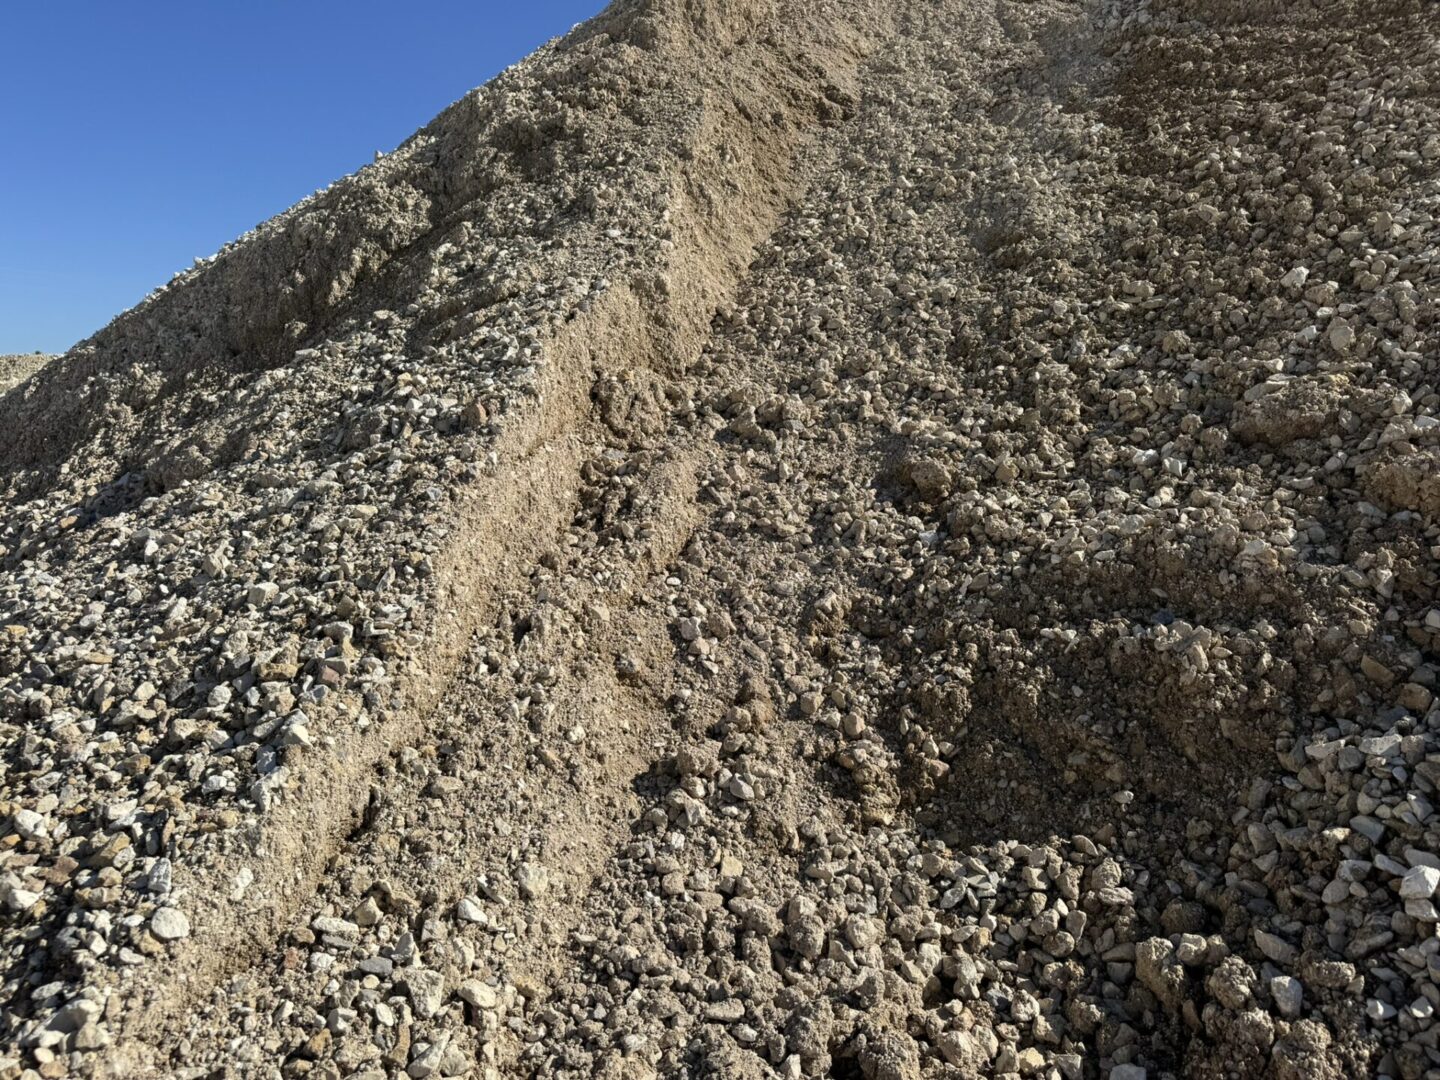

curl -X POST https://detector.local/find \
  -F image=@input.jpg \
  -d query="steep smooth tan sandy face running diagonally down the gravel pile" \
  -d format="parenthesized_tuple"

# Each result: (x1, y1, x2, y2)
(90, 6, 887, 1076)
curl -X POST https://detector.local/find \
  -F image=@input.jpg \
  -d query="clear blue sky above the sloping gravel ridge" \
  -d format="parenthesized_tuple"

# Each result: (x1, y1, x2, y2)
(0, 0, 605, 353)
